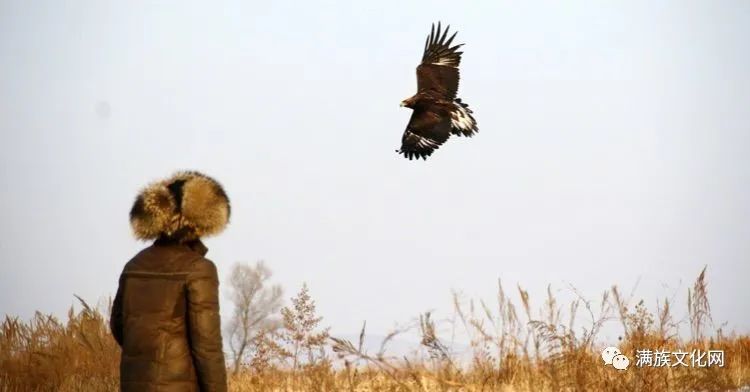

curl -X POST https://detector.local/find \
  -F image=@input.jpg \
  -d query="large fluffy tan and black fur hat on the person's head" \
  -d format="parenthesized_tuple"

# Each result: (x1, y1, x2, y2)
(130, 171, 231, 242)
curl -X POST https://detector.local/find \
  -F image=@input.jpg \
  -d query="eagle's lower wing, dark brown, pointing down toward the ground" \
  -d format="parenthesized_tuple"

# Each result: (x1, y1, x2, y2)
(396, 109, 451, 160)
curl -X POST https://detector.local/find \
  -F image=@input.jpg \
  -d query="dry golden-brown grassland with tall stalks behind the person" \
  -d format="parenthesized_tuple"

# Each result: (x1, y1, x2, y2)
(0, 269, 750, 392)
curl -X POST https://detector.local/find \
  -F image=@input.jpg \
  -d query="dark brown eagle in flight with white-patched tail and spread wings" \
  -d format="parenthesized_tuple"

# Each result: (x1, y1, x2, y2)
(396, 22, 479, 160)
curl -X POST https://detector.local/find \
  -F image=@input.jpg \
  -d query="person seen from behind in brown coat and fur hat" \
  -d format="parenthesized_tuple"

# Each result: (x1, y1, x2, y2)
(110, 172, 229, 392)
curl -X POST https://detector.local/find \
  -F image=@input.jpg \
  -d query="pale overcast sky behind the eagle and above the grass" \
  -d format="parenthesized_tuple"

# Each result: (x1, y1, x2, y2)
(0, 0, 750, 342)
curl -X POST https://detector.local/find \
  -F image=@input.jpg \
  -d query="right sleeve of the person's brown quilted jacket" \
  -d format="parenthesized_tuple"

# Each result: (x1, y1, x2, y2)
(187, 258, 227, 392)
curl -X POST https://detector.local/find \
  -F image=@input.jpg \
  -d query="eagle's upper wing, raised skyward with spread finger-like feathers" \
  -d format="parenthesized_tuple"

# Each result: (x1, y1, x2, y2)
(417, 22, 463, 100)
